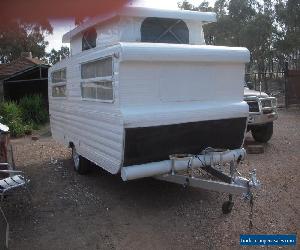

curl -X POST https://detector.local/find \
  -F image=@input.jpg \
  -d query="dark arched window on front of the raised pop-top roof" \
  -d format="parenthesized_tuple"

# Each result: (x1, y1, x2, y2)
(141, 17, 189, 44)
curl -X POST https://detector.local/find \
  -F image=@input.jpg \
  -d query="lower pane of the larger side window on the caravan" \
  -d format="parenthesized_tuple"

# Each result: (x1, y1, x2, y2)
(81, 81, 113, 101)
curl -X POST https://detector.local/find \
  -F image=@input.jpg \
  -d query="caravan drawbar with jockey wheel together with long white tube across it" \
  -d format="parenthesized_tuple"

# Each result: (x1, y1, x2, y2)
(121, 148, 260, 213)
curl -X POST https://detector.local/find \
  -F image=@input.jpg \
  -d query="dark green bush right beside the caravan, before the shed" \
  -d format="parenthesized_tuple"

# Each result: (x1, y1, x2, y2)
(19, 95, 48, 127)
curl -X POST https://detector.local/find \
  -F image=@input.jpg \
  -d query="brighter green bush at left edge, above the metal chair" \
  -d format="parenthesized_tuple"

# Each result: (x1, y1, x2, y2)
(0, 102, 25, 136)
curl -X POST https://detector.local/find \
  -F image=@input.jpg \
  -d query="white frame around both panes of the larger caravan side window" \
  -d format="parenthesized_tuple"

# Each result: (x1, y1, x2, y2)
(80, 55, 115, 104)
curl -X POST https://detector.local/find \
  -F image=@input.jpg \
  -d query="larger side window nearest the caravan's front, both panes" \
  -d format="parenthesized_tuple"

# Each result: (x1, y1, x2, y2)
(81, 57, 114, 102)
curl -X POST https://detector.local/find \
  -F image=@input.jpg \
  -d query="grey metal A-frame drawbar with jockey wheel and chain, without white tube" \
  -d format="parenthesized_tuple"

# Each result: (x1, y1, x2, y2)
(155, 150, 260, 214)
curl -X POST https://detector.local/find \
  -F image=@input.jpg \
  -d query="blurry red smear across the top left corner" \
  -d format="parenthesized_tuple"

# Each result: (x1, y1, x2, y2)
(0, 0, 128, 24)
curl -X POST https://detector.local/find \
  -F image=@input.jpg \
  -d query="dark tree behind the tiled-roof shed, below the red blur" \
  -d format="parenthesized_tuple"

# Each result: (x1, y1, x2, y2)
(0, 20, 52, 63)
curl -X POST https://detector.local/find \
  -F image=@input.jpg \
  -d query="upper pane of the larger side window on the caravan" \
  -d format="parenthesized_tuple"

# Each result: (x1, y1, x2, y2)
(81, 57, 112, 79)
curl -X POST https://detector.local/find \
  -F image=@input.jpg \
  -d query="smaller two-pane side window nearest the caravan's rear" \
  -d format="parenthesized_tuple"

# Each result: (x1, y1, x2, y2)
(51, 68, 67, 97)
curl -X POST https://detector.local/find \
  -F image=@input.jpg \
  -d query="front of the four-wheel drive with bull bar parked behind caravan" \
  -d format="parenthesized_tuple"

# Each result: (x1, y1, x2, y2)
(244, 86, 278, 142)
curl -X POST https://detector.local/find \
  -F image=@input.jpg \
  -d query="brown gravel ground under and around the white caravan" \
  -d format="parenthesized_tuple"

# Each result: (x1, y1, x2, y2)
(4, 109, 300, 249)
